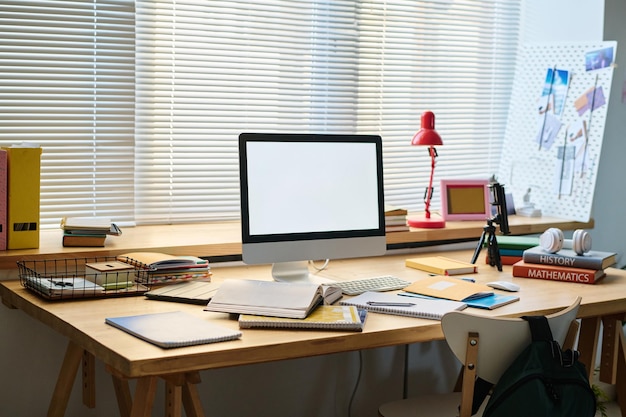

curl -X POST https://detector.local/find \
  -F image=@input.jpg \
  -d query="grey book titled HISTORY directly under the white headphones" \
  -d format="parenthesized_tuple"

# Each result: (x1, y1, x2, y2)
(523, 246, 616, 270)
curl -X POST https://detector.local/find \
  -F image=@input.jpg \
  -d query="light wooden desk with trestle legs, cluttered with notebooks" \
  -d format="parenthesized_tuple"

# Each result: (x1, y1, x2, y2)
(0, 251, 626, 416)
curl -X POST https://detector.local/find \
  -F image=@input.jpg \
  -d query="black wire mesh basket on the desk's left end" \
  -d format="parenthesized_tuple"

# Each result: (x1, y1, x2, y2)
(17, 257, 150, 300)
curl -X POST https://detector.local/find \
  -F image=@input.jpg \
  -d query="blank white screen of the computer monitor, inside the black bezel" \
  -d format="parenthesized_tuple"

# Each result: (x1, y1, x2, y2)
(246, 142, 379, 235)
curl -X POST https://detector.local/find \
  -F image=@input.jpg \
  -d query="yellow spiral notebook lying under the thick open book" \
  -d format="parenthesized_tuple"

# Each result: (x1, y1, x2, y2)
(239, 305, 367, 332)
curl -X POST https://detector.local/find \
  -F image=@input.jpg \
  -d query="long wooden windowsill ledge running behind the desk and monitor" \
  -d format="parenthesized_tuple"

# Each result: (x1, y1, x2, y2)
(0, 215, 594, 270)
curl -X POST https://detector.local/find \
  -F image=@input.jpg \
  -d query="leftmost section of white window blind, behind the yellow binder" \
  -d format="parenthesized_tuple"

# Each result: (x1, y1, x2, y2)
(0, 0, 135, 227)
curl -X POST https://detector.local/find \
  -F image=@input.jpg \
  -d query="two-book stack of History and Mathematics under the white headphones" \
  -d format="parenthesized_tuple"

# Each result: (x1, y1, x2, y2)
(513, 246, 616, 284)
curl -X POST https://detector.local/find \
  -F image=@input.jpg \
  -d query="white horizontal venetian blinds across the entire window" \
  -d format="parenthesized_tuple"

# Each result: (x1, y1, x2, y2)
(0, 0, 520, 226)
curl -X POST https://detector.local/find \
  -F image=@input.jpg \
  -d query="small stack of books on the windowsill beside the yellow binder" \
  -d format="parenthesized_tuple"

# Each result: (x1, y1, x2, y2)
(61, 217, 122, 246)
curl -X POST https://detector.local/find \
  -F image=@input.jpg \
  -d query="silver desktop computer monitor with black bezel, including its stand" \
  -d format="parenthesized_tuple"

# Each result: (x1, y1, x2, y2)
(239, 133, 386, 281)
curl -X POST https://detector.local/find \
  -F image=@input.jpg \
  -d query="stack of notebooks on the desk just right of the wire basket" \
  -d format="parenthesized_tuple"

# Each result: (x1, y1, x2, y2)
(117, 252, 211, 285)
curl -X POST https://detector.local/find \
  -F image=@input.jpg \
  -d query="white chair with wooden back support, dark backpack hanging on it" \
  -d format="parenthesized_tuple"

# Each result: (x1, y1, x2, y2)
(378, 297, 581, 417)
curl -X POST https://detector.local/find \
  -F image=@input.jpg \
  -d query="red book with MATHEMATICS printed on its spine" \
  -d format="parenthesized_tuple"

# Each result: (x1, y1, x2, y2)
(513, 261, 606, 284)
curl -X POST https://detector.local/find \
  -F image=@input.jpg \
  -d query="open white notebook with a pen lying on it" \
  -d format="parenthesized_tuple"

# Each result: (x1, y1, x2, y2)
(340, 291, 467, 320)
